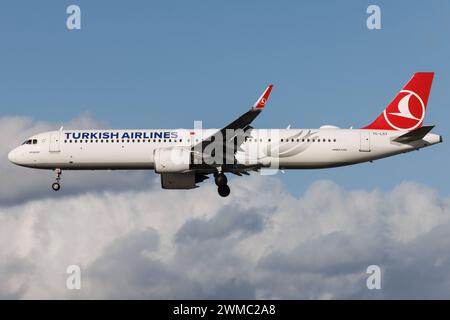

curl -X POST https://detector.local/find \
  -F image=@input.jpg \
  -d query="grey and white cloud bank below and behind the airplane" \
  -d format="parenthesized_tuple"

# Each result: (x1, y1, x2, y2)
(0, 118, 450, 299)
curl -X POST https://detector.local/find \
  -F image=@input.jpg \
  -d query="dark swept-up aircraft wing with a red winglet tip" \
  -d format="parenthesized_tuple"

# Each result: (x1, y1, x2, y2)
(193, 84, 273, 161)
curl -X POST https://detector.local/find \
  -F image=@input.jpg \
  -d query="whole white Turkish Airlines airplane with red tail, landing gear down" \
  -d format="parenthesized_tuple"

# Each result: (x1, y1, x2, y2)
(8, 72, 443, 197)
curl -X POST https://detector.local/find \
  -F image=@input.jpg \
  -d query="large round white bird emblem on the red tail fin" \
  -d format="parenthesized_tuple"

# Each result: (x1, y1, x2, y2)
(384, 90, 425, 130)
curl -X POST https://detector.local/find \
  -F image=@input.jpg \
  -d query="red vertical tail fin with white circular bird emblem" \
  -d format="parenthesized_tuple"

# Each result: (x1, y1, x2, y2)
(363, 72, 434, 131)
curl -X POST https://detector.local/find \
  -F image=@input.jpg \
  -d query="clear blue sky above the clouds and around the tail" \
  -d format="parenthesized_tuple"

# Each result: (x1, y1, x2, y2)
(0, 0, 450, 195)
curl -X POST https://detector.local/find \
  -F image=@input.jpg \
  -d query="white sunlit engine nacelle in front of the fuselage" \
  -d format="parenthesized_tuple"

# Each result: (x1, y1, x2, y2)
(153, 147, 191, 173)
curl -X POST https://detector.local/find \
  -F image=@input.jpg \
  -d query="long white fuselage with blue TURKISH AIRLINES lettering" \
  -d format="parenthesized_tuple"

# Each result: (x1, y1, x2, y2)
(8, 127, 442, 170)
